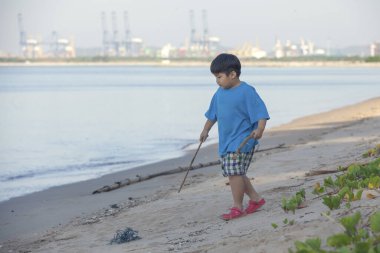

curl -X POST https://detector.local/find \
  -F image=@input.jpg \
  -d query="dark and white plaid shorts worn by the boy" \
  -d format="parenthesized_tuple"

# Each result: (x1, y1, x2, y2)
(221, 149, 254, 177)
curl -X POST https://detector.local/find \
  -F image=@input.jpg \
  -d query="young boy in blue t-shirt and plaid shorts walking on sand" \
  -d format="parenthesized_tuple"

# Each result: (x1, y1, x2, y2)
(199, 54, 269, 220)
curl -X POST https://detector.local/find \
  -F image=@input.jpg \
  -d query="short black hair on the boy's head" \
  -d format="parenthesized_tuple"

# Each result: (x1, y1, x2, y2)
(210, 53, 241, 77)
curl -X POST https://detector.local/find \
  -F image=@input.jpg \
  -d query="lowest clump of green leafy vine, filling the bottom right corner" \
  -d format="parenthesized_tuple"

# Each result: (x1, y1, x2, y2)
(289, 211, 380, 253)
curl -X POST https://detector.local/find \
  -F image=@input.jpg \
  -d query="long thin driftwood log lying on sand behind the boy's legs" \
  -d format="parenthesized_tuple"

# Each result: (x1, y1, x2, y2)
(92, 143, 285, 194)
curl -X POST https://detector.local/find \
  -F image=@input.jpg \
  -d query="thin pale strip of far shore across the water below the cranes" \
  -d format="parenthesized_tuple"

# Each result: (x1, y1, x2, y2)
(0, 60, 380, 68)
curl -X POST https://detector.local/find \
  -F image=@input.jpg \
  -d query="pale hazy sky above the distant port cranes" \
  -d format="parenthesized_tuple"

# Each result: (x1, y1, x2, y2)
(0, 0, 380, 54)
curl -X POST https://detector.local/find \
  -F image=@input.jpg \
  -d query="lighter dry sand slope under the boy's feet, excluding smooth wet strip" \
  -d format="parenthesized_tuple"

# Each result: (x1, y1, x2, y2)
(0, 98, 380, 252)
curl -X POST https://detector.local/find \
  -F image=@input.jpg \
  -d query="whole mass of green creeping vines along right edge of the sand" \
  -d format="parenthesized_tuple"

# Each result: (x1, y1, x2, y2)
(289, 151, 380, 253)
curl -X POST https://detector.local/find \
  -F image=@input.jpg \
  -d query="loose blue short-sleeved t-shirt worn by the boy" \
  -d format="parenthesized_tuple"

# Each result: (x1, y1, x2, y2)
(205, 82, 269, 156)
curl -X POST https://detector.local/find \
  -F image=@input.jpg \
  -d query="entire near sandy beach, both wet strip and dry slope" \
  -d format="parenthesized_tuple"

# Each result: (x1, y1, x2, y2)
(0, 97, 380, 252)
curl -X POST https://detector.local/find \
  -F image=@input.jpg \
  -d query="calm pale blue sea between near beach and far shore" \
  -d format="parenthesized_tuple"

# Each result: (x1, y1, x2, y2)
(0, 66, 380, 201)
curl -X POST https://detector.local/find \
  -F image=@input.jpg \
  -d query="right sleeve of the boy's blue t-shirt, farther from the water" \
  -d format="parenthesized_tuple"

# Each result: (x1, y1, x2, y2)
(246, 89, 270, 125)
